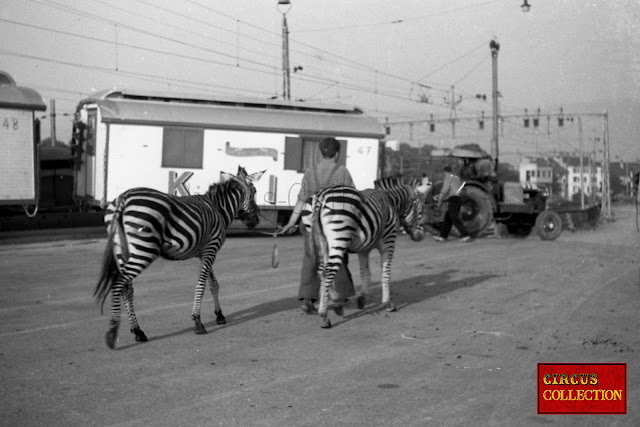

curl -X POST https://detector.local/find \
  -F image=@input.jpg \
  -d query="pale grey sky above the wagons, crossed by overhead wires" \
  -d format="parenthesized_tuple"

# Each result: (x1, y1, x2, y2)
(0, 0, 640, 163)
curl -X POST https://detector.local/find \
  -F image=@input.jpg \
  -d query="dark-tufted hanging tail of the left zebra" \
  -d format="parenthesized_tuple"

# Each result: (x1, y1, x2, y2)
(93, 197, 128, 313)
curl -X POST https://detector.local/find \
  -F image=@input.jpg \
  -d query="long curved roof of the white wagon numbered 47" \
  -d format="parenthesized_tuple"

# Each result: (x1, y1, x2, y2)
(78, 91, 385, 139)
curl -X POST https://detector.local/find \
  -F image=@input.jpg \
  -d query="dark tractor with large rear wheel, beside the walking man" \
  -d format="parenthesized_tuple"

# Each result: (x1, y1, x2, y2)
(424, 149, 562, 240)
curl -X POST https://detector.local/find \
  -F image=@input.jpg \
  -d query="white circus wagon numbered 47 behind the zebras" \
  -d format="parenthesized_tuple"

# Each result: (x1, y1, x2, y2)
(73, 90, 385, 228)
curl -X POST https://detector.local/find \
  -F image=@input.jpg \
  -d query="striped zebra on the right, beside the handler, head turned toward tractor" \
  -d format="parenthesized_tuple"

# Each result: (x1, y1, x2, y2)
(303, 177, 424, 328)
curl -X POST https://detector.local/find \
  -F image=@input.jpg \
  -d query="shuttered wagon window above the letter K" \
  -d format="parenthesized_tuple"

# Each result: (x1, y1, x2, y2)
(162, 127, 204, 169)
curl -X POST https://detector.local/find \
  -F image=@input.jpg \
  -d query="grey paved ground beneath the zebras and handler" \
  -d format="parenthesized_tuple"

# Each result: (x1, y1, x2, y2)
(0, 207, 640, 426)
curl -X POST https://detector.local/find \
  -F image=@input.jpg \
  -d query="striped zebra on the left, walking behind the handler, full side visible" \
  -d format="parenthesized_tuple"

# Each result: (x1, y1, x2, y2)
(93, 167, 264, 348)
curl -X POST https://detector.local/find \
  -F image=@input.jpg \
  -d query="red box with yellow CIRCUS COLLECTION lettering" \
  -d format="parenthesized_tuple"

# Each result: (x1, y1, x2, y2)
(537, 363, 627, 415)
